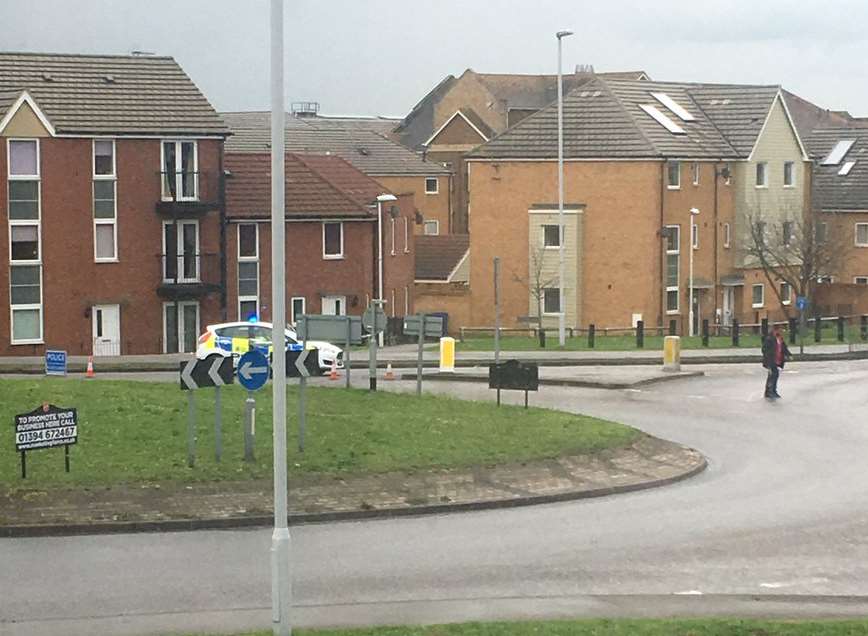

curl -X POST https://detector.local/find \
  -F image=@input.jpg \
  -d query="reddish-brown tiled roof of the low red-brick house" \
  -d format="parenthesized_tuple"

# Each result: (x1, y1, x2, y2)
(225, 153, 384, 218)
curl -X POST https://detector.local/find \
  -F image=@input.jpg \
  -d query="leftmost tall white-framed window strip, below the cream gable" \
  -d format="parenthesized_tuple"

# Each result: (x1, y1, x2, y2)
(6, 137, 45, 345)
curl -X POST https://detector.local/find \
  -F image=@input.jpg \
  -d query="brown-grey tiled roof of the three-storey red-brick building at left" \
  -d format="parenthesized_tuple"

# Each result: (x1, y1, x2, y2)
(0, 53, 228, 135)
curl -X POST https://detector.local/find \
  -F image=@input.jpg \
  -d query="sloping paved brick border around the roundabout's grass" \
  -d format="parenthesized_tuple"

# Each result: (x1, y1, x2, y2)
(0, 435, 706, 537)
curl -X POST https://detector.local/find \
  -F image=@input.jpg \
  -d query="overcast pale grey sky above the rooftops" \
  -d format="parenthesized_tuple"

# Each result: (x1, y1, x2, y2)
(0, 0, 868, 115)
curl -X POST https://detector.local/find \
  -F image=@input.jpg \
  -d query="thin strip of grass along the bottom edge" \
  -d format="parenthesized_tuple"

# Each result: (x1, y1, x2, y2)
(188, 619, 868, 636)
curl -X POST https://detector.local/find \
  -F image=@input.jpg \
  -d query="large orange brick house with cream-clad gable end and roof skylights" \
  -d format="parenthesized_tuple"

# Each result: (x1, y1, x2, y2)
(467, 77, 810, 333)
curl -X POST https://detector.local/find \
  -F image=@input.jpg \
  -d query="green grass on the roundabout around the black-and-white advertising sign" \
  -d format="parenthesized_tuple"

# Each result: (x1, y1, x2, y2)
(0, 378, 640, 487)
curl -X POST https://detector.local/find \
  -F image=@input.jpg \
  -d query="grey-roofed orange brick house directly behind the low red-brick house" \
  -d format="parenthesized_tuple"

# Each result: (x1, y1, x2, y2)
(223, 112, 452, 234)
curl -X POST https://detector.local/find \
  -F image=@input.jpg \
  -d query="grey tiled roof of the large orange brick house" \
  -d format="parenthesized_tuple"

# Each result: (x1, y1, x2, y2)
(469, 77, 779, 159)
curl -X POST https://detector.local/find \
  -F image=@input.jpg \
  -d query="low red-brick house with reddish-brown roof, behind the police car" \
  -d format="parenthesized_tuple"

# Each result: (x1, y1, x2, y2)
(226, 152, 415, 323)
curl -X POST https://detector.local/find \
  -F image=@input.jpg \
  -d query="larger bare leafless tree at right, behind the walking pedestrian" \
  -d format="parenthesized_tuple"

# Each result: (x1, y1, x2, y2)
(745, 212, 844, 350)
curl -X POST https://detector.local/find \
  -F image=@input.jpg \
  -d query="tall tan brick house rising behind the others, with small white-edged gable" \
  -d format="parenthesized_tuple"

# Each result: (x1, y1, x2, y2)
(392, 68, 647, 234)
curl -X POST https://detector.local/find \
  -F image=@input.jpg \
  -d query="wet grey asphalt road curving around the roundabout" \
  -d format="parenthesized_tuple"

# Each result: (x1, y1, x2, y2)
(0, 362, 868, 636)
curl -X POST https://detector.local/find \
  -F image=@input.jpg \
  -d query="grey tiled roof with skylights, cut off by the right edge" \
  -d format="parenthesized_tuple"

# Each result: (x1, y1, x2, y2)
(805, 128, 868, 211)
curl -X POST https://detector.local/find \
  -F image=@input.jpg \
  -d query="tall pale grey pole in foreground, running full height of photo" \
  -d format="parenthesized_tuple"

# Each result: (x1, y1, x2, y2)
(271, 0, 292, 636)
